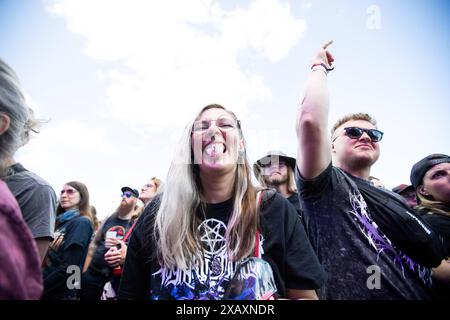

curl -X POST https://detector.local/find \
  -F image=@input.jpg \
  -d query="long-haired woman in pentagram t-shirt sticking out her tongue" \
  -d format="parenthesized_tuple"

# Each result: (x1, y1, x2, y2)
(119, 105, 325, 300)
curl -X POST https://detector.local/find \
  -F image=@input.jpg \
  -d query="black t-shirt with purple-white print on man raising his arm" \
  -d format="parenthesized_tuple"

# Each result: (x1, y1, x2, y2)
(296, 164, 431, 299)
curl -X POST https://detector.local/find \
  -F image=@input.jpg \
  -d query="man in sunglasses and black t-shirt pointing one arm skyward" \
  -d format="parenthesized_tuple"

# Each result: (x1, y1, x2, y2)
(296, 42, 438, 299)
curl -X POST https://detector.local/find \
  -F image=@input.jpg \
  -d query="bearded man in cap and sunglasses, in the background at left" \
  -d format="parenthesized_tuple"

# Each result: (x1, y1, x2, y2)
(80, 187, 139, 300)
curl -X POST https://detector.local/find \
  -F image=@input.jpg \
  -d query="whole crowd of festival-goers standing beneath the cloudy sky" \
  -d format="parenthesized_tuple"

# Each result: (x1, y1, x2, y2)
(0, 42, 450, 300)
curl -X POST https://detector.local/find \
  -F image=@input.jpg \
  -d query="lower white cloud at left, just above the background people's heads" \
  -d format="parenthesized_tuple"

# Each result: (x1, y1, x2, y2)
(15, 121, 122, 218)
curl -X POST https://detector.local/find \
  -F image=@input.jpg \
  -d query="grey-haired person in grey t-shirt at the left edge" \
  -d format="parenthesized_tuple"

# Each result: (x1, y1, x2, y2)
(0, 59, 56, 261)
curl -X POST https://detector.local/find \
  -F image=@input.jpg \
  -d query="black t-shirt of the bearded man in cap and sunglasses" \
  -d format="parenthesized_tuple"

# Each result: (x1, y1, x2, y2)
(89, 215, 130, 277)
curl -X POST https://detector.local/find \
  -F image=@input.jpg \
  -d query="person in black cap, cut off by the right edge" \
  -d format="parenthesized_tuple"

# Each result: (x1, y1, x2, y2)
(411, 153, 450, 299)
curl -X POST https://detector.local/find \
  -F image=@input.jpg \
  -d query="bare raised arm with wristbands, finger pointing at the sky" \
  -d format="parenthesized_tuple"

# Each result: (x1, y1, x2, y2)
(297, 41, 334, 179)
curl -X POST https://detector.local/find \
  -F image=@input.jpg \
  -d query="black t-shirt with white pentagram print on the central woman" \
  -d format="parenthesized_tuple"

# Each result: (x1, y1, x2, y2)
(119, 194, 325, 300)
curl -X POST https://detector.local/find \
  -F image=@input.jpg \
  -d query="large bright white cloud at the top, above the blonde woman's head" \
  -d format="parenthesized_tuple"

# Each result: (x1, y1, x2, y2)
(46, 0, 306, 128)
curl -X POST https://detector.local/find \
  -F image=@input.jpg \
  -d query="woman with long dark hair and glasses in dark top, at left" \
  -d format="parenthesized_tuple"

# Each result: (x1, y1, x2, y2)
(42, 181, 93, 300)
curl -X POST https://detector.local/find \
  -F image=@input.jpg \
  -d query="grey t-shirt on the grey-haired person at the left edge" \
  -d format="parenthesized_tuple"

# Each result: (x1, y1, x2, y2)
(4, 163, 57, 239)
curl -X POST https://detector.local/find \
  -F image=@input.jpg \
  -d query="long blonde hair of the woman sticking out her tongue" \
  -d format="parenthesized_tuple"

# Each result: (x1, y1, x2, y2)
(154, 104, 259, 270)
